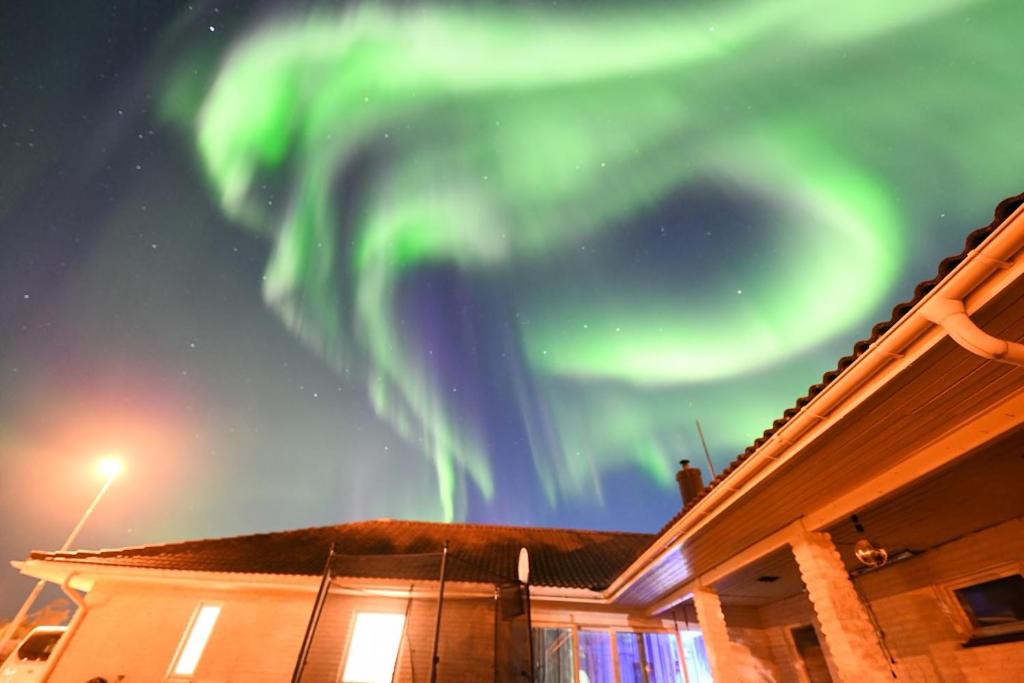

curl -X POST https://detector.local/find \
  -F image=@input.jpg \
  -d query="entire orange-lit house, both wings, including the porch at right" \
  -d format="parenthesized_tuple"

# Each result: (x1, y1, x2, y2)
(9, 196, 1024, 683)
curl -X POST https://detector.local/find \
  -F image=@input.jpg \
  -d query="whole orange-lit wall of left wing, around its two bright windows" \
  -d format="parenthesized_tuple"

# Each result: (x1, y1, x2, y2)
(50, 580, 557, 683)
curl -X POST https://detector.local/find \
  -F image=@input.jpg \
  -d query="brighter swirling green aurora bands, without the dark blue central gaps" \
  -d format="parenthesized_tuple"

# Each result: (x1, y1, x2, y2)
(172, 0, 1011, 518)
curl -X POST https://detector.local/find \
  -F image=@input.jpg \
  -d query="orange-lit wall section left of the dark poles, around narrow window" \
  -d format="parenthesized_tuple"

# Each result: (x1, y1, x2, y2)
(50, 582, 314, 683)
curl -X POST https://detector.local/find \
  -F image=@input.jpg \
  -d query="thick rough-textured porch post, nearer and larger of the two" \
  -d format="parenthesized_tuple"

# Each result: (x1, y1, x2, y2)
(791, 529, 896, 683)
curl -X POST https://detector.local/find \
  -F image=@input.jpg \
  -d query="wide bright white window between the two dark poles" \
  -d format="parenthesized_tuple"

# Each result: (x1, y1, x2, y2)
(341, 612, 406, 683)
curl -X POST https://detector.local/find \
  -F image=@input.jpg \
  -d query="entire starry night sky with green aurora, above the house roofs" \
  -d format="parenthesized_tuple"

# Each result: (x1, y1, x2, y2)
(0, 0, 1024, 612)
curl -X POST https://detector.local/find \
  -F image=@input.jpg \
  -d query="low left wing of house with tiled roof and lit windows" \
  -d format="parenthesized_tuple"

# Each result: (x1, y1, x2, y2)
(14, 519, 679, 682)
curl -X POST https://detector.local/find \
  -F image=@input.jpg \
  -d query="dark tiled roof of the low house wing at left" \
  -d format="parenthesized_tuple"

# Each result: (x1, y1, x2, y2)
(30, 519, 654, 591)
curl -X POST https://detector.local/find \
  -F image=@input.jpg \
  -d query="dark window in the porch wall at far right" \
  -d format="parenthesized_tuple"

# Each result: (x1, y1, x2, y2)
(953, 574, 1024, 644)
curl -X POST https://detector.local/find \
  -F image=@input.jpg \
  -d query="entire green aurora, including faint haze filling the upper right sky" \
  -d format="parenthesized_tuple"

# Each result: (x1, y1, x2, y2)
(168, 0, 1024, 519)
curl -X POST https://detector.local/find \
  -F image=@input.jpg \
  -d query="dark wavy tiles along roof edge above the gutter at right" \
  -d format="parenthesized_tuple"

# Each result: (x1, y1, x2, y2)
(657, 189, 1024, 536)
